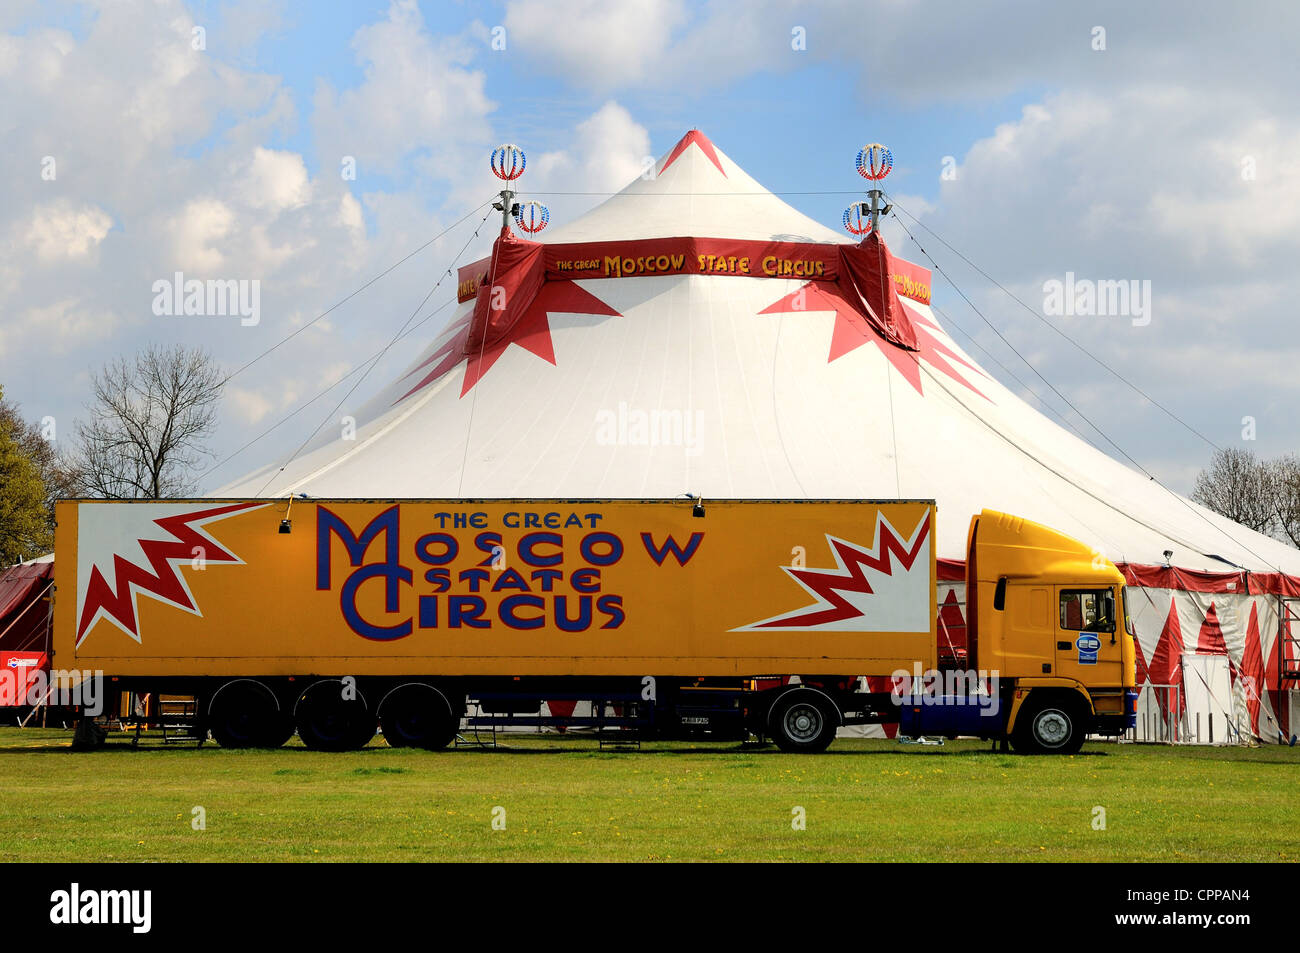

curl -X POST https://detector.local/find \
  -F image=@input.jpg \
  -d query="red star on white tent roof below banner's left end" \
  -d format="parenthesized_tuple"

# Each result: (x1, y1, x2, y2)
(393, 281, 620, 404)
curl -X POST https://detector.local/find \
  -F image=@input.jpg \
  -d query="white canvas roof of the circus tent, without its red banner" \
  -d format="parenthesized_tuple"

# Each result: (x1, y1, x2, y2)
(215, 133, 1300, 573)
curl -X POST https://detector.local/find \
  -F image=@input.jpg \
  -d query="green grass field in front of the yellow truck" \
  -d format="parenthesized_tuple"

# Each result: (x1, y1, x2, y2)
(0, 728, 1300, 862)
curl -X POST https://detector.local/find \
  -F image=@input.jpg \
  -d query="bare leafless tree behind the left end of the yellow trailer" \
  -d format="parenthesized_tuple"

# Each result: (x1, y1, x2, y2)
(73, 346, 224, 499)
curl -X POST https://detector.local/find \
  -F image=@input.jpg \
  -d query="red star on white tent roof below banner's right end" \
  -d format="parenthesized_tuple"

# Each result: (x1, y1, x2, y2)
(758, 281, 989, 400)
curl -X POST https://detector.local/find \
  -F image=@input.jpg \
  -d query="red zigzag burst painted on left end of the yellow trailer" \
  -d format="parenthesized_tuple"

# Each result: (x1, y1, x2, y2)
(77, 502, 265, 645)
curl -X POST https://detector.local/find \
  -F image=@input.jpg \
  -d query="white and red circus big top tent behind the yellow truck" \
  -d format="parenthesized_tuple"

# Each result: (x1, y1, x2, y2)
(213, 131, 1300, 740)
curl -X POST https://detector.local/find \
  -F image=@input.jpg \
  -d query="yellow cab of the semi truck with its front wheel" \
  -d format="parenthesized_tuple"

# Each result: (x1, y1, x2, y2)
(966, 510, 1138, 753)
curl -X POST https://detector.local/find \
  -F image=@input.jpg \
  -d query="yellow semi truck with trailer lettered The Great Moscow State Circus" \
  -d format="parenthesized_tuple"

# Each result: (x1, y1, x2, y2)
(53, 498, 1136, 751)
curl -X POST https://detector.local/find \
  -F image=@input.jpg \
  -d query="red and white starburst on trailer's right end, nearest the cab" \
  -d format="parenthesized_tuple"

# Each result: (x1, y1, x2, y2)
(736, 514, 933, 632)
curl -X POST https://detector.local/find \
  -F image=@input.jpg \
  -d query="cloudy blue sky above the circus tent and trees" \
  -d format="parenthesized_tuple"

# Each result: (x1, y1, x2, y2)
(0, 0, 1300, 491)
